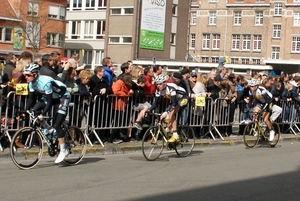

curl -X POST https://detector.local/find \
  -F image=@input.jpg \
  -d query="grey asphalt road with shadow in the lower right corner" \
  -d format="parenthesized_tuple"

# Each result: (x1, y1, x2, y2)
(0, 141, 300, 201)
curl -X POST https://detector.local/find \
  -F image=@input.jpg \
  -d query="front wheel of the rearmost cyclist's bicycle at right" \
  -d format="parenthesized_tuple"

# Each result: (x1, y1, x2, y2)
(243, 122, 259, 148)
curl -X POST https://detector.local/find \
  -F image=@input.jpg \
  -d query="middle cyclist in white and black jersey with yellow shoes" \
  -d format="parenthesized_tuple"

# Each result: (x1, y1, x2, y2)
(149, 72, 195, 143)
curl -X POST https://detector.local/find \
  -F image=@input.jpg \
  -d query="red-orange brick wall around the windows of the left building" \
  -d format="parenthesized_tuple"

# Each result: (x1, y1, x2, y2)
(0, 0, 67, 54)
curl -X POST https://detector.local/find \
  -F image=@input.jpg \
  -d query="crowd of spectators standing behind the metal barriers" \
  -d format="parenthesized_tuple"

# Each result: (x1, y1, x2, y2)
(0, 51, 300, 143)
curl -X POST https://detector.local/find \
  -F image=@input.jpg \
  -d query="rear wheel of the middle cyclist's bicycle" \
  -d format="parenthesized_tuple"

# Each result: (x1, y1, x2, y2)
(175, 125, 195, 157)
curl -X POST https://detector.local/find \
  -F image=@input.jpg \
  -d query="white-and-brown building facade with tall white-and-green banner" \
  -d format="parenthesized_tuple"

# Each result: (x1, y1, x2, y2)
(65, 0, 190, 69)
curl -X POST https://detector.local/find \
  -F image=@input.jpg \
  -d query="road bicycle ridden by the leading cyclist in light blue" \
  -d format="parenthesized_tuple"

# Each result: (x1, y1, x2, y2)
(10, 111, 86, 170)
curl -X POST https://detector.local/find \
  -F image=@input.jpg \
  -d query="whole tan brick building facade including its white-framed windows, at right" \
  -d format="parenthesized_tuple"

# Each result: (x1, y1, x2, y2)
(189, 0, 300, 73)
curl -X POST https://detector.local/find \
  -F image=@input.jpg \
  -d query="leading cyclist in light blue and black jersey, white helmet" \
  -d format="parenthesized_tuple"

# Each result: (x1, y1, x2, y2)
(23, 63, 70, 163)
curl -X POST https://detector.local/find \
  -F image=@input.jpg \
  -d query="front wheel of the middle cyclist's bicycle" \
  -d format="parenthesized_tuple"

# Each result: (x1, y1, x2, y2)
(142, 126, 164, 161)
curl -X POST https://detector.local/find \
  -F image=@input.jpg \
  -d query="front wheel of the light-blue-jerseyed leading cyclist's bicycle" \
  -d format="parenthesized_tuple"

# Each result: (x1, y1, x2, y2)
(10, 127, 43, 170)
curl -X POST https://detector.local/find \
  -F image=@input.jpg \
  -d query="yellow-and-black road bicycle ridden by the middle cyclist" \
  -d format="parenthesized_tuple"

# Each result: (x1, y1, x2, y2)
(142, 113, 195, 161)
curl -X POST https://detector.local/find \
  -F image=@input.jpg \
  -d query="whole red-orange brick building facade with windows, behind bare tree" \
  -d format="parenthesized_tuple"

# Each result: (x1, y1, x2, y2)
(0, 0, 67, 56)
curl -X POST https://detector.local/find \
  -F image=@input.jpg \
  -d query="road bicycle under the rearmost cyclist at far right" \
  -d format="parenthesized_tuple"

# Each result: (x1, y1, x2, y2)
(243, 112, 280, 148)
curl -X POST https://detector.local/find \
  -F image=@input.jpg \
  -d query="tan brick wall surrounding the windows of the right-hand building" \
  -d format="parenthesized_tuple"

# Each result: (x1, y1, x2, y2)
(189, 0, 300, 72)
